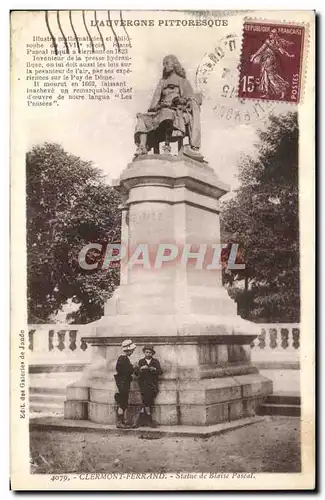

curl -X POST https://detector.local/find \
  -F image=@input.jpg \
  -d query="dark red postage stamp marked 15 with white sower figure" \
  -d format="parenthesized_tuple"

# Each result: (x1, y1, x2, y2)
(238, 21, 305, 103)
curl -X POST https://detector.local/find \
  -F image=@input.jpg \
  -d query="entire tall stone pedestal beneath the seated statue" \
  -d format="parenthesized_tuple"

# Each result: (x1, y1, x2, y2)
(65, 155, 272, 425)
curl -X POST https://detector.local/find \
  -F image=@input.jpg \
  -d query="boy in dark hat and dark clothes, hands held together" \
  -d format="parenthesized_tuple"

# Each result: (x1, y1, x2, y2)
(135, 345, 162, 427)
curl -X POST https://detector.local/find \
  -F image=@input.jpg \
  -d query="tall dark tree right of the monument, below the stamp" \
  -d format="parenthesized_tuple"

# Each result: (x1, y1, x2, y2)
(221, 112, 300, 322)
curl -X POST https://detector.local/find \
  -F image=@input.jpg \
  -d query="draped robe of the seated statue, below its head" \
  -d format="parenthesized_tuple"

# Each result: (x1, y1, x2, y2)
(135, 73, 201, 149)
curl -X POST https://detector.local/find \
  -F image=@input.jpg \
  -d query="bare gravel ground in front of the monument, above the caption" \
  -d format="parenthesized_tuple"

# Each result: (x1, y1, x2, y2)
(30, 417, 300, 474)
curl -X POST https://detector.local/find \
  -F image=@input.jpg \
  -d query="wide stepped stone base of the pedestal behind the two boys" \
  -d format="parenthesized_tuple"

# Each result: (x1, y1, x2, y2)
(65, 336, 272, 426)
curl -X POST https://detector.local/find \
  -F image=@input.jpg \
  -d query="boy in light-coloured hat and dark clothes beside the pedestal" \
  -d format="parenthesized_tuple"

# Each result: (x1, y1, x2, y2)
(114, 340, 136, 429)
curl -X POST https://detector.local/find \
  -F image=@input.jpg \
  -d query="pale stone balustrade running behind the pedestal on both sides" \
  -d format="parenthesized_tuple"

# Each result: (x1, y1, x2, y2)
(28, 323, 300, 367)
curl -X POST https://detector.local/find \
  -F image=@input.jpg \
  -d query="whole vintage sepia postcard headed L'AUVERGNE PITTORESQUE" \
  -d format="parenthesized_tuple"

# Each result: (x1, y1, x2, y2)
(10, 10, 315, 491)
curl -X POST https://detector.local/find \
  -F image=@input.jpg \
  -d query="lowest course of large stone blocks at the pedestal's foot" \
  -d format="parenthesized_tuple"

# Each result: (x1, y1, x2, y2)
(65, 373, 272, 426)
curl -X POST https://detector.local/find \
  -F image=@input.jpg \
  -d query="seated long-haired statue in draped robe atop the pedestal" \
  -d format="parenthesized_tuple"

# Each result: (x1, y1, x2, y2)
(134, 55, 203, 161)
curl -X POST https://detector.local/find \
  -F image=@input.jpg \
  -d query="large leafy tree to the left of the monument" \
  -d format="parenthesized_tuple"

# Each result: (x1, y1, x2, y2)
(26, 143, 121, 323)
